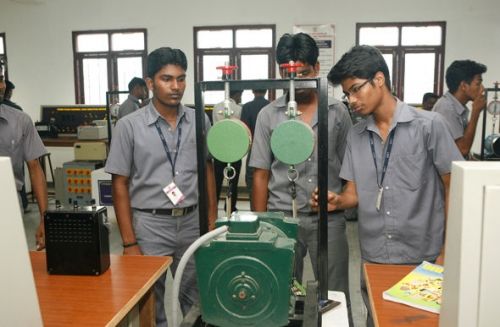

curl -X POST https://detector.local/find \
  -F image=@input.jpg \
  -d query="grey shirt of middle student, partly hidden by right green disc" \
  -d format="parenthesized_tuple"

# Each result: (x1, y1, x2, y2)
(249, 96, 352, 214)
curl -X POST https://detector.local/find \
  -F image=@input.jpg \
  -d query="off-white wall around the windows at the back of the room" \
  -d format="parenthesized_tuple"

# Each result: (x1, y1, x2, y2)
(0, 0, 500, 153)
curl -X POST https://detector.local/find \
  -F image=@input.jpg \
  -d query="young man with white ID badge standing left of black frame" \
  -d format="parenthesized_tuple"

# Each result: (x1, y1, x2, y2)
(105, 48, 217, 326)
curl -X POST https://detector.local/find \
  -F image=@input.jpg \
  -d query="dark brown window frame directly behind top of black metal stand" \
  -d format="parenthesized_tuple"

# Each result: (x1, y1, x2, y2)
(193, 24, 276, 99)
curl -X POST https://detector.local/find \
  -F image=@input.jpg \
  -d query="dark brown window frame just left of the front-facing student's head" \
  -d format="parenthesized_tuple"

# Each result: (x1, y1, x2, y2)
(72, 28, 148, 104)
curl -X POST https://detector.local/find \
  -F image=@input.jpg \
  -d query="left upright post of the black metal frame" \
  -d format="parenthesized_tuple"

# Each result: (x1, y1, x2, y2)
(194, 83, 208, 235)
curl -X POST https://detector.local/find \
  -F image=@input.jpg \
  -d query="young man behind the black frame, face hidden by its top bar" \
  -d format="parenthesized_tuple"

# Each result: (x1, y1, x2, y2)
(249, 33, 352, 320)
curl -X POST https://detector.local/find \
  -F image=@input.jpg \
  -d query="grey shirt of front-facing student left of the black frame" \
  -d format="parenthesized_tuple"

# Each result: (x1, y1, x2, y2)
(105, 102, 210, 209)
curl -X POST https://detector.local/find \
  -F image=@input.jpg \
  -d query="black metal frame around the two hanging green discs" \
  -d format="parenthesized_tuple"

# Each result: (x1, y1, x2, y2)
(195, 78, 328, 304)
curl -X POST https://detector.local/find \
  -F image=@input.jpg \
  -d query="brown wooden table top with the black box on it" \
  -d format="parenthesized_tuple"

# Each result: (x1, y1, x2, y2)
(30, 252, 172, 326)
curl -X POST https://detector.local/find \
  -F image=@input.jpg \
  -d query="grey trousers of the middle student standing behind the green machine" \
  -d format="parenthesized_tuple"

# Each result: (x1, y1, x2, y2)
(295, 213, 352, 326)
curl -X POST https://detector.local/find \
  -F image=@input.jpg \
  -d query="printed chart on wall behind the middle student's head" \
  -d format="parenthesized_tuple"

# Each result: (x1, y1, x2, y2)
(293, 24, 335, 96)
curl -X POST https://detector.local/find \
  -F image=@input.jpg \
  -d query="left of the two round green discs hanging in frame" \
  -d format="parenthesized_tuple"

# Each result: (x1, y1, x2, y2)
(207, 119, 252, 162)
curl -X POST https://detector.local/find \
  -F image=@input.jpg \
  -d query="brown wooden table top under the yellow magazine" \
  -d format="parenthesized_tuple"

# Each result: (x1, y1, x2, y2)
(364, 263, 439, 327)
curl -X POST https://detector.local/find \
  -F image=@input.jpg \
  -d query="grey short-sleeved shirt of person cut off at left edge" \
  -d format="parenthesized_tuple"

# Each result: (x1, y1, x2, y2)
(0, 104, 47, 191)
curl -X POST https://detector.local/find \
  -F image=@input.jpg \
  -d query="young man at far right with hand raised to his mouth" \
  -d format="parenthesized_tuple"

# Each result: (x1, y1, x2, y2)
(432, 60, 486, 157)
